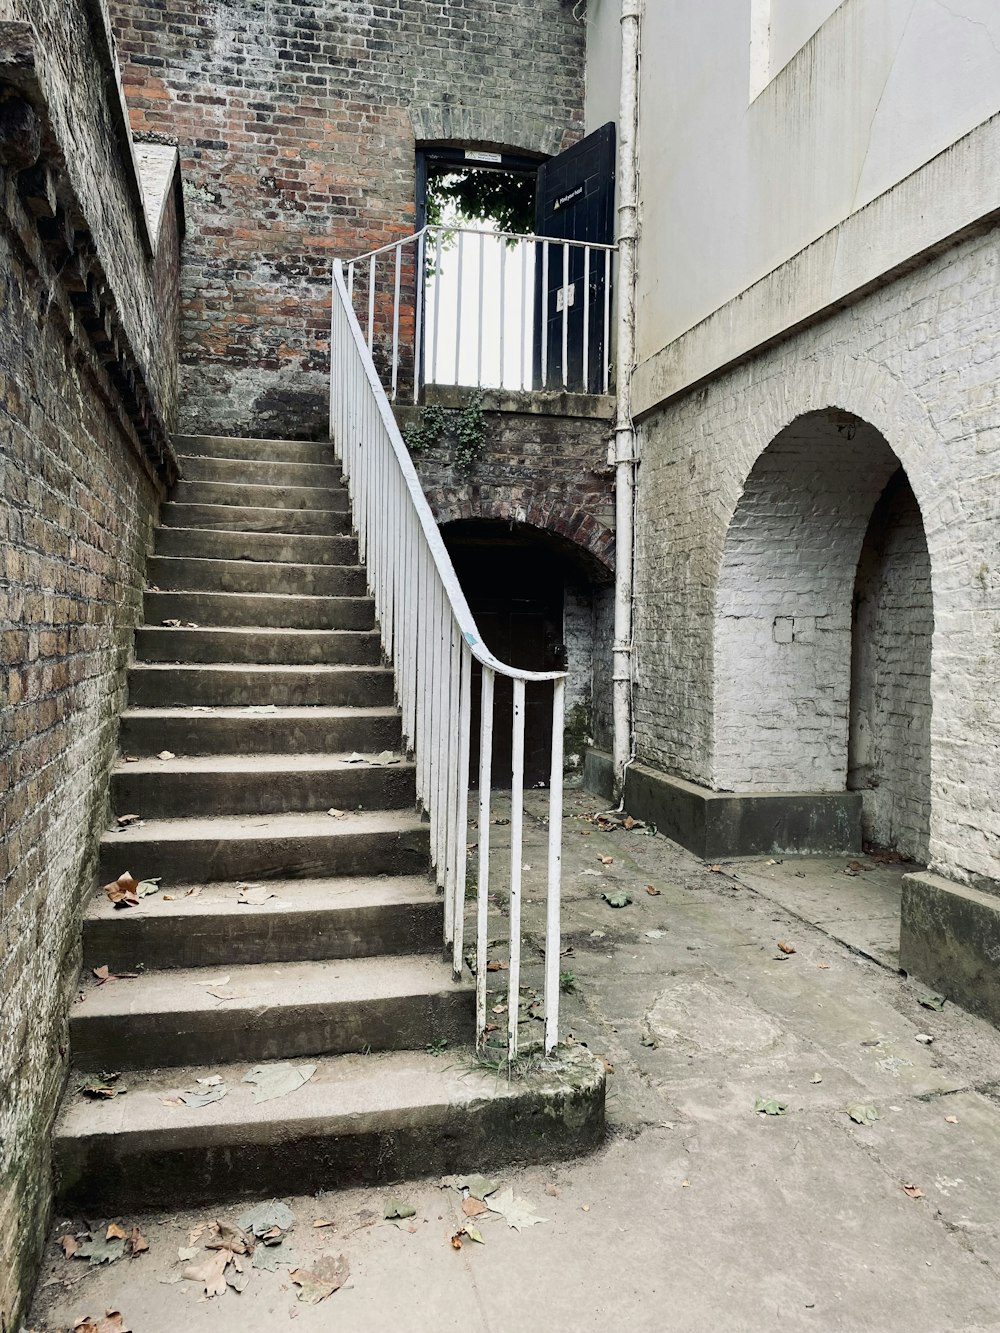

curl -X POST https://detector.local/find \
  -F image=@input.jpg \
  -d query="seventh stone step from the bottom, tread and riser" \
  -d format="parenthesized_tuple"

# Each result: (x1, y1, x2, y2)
(128, 663, 395, 708)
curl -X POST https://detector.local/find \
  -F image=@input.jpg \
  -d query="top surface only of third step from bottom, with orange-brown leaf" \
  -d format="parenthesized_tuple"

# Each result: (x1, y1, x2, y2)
(84, 874, 441, 921)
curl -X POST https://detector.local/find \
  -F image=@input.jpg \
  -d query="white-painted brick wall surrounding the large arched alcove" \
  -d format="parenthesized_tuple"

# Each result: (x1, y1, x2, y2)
(636, 231, 1000, 888)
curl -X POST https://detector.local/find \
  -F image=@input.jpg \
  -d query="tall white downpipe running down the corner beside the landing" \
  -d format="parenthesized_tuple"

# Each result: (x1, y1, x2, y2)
(612, 0, 643, 800)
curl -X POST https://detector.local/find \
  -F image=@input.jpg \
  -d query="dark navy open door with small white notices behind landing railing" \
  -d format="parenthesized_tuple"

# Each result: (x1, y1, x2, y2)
(535, 121, 616, 393)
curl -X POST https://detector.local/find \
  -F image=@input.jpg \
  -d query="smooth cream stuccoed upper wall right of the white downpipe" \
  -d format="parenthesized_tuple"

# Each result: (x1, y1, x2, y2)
(634, 0, 1000, 391)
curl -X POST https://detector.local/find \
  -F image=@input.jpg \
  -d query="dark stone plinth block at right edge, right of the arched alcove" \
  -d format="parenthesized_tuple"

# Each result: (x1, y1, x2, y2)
(899, 870, 1000, 1026)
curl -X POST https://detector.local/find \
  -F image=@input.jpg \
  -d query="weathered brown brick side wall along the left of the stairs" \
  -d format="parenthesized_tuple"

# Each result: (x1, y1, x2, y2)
(0, 0, 179, 1333)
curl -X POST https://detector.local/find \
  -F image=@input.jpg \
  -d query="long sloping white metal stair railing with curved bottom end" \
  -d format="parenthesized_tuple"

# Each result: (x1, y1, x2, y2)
(329, 260, 565, 1058)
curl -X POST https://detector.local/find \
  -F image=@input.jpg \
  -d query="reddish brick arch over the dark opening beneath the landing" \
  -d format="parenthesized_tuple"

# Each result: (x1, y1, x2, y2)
(424, 484, 615, 583)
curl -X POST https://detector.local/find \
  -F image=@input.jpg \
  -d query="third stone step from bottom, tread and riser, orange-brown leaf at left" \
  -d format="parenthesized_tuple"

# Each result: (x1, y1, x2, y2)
(83, 876, 444, 972)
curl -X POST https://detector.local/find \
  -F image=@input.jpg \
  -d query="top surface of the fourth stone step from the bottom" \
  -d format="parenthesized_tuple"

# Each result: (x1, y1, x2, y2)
(101, 810, 425, 852)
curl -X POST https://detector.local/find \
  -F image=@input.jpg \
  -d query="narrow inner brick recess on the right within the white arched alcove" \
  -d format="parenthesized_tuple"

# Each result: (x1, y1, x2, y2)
(848, 473, 933, 861)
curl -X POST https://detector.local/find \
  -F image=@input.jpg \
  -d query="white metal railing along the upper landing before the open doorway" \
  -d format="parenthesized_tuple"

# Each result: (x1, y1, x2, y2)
(347, 225, 617, 403)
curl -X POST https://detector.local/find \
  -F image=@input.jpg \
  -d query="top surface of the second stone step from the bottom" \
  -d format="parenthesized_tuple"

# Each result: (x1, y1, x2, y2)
(71, 954, 471, 1022)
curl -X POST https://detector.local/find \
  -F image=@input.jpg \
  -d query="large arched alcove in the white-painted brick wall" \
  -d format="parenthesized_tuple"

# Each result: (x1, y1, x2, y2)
(713, 409, 933, 857)
